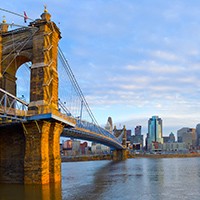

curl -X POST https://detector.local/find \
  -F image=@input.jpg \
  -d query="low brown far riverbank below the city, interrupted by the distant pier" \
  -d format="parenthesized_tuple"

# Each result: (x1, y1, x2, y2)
(61, 153, 200, 162)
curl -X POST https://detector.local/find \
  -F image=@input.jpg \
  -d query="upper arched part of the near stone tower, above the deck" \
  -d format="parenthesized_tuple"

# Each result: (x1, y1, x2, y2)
(0, 9, 61, 114)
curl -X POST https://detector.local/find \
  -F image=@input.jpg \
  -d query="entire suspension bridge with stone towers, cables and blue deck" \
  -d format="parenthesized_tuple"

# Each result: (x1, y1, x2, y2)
(0, 8, 126, 184)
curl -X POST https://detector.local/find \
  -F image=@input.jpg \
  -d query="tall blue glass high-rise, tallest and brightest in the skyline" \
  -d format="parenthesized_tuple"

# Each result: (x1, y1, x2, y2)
(147, 116, 163, 147)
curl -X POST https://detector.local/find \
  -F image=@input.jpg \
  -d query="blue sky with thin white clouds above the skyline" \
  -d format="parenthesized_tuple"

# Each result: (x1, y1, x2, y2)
(0, 0, 200, 138)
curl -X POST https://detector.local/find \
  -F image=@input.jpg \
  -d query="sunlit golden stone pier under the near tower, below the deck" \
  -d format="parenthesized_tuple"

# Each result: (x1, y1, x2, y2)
(24, 121, 63, 184)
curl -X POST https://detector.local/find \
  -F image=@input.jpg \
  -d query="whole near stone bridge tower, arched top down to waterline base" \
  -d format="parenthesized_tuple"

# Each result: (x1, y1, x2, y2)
(0, 9, 75, 184)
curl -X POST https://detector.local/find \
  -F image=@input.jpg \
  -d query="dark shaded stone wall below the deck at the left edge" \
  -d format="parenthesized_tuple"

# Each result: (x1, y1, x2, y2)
(0, 125, 25, 183)
